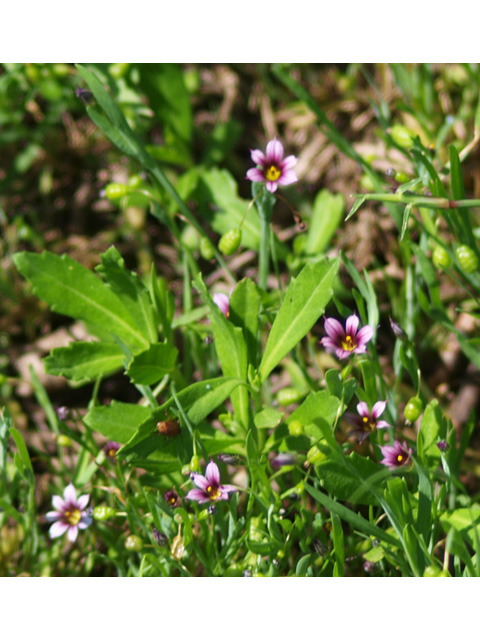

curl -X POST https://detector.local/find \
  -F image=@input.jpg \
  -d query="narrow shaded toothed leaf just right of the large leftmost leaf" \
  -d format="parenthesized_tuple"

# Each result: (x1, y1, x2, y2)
(95, 247, 158, 343)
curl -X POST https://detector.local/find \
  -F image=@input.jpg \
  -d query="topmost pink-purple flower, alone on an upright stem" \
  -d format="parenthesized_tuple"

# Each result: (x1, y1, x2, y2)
(247, 138, 298, 193)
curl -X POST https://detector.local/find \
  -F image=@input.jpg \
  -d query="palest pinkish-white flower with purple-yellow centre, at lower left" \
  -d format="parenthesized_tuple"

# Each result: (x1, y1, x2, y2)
(46, 483, 92, 542)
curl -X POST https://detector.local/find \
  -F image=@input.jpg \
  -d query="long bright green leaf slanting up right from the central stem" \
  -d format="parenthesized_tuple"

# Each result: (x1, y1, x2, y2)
(259, 258, 340, 380)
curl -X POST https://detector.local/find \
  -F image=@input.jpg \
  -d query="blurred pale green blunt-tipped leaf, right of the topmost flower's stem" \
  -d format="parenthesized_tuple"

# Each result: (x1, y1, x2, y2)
(304, 189, 345, 255)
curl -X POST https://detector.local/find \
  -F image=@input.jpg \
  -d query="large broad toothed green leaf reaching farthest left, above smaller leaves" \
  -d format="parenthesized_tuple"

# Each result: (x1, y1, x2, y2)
(13, 251, 148, 349)
